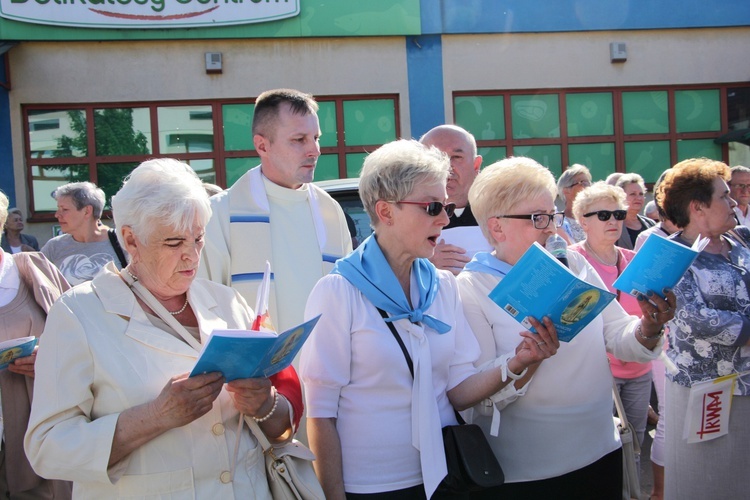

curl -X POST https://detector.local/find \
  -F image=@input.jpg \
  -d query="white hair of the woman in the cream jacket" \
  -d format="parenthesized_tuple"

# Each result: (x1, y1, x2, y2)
(112, 158, 211, 244)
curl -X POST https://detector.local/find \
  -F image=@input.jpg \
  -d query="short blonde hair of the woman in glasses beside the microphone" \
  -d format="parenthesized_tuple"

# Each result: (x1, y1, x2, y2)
(469, 156, 556, 244)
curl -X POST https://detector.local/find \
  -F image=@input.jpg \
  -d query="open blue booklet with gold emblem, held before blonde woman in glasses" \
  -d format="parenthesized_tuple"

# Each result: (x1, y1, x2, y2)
(489, 242, 615, 342)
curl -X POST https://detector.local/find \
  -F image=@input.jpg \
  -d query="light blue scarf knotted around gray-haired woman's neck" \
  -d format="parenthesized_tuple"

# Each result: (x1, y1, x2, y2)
(331, 234, 451, 333)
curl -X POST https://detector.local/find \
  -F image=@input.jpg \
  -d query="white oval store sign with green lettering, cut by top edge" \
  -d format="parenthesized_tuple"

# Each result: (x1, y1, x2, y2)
(0, 0, 300, 29)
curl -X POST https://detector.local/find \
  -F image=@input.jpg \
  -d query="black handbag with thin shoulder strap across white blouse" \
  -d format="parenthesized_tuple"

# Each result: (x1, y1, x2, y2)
(378, 308, 505, 493)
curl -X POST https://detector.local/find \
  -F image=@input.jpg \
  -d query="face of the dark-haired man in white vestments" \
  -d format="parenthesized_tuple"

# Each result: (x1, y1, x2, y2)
(253, 103, 320, 189)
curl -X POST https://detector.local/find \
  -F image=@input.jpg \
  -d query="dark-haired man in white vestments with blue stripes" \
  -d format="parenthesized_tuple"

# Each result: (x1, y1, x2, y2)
(199, 89, 352, 332)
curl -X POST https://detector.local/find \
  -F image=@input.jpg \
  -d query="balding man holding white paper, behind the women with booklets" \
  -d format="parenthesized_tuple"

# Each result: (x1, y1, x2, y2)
(419, 125, 484, 275)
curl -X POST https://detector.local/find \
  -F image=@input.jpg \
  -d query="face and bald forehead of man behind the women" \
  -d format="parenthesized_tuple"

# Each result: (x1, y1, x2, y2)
(424, 130, 482, 208)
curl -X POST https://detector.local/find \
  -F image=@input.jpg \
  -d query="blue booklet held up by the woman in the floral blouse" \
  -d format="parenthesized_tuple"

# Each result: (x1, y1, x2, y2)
(613, 233, 708, 297)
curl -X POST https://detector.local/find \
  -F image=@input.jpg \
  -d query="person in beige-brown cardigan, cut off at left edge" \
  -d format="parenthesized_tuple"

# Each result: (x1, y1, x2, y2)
(0, 192, 70, 499)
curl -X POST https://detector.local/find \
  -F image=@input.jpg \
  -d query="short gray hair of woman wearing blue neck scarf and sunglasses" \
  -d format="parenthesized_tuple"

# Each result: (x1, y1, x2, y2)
(359, 139, 450, 227)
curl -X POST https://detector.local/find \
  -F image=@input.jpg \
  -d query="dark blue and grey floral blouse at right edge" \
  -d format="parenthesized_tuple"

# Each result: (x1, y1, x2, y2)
(667, 233, 750, 396)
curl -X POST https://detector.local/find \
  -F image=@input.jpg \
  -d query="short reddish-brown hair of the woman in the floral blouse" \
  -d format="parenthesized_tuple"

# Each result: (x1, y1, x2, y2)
(656, 158, 731, 227)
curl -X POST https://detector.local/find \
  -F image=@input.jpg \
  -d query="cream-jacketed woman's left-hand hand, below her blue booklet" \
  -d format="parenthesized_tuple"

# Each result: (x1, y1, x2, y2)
(151, 372, 224, 428)
